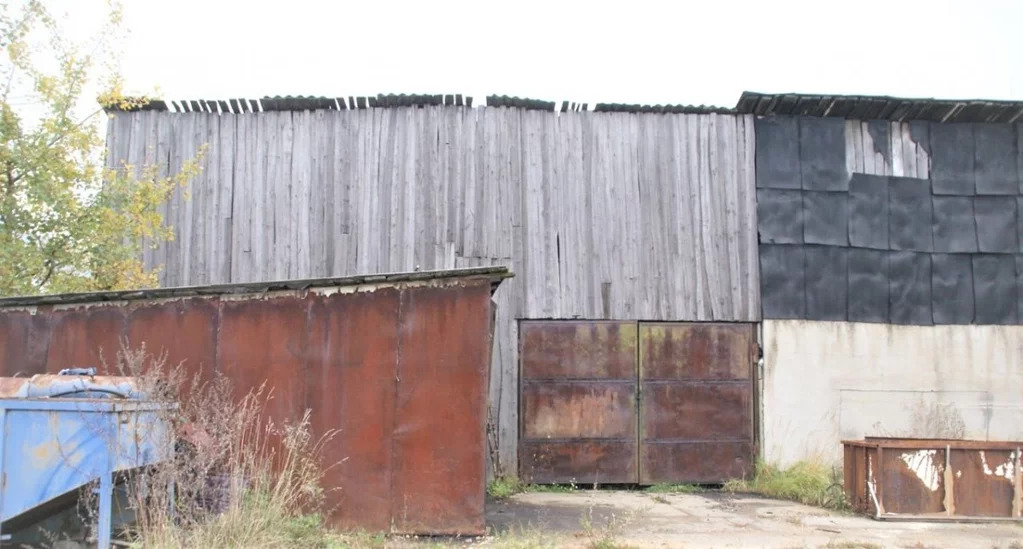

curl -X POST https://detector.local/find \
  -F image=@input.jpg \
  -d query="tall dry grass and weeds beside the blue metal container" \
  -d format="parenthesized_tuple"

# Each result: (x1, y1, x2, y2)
(107, 344, 332, 549)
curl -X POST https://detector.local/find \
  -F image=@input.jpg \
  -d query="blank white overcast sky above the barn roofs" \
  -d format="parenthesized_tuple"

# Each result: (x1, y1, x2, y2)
(53, 0, 1023, 106)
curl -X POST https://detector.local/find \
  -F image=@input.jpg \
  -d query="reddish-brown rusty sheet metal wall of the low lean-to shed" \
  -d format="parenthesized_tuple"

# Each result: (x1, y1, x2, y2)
(0, 276, 500, 534)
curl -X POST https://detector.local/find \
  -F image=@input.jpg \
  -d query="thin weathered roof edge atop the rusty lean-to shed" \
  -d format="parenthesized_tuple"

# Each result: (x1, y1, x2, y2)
(0, 266, 515, 309)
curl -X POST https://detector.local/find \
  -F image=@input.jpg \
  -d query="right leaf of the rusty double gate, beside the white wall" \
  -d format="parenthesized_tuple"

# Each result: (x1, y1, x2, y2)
(639, 322, 756, 484)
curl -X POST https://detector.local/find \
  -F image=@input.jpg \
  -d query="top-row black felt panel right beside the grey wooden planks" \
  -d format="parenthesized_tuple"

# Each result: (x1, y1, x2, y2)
(754, 117, 802, 189)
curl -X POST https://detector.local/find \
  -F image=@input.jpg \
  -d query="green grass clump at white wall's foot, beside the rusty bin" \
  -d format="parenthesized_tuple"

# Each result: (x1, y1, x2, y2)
(722, 461, 849, 510)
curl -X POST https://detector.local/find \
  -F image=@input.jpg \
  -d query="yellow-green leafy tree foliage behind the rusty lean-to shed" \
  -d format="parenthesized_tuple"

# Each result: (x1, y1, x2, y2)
(0, 0, 198, 295)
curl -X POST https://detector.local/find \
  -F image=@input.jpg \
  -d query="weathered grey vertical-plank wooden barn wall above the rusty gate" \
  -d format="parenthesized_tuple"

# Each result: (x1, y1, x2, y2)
(107, 106, 760, 472)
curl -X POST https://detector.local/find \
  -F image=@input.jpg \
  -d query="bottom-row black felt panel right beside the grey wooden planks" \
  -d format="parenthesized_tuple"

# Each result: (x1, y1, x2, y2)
(760, 244, 806, 319)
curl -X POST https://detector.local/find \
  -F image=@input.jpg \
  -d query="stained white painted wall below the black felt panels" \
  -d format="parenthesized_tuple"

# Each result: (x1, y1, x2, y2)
(762, 320, 1023, 465)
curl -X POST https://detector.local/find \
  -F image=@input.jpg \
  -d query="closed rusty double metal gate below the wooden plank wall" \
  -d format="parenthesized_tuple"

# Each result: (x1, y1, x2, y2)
(519, 321, 756, 484)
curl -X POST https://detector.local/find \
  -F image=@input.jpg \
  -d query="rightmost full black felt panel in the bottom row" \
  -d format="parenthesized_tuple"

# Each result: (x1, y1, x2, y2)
(973, 254, 1018, 324)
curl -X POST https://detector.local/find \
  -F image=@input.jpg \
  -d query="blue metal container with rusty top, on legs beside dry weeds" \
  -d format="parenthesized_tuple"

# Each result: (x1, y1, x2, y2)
(0, 376, 172, 548)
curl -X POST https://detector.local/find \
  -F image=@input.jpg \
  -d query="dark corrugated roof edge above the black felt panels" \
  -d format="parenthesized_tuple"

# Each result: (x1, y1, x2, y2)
(736, 92, 1023, 123)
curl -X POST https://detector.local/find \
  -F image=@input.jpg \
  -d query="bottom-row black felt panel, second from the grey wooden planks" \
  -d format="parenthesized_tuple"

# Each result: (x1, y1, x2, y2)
(805, 246, 848, 320)
